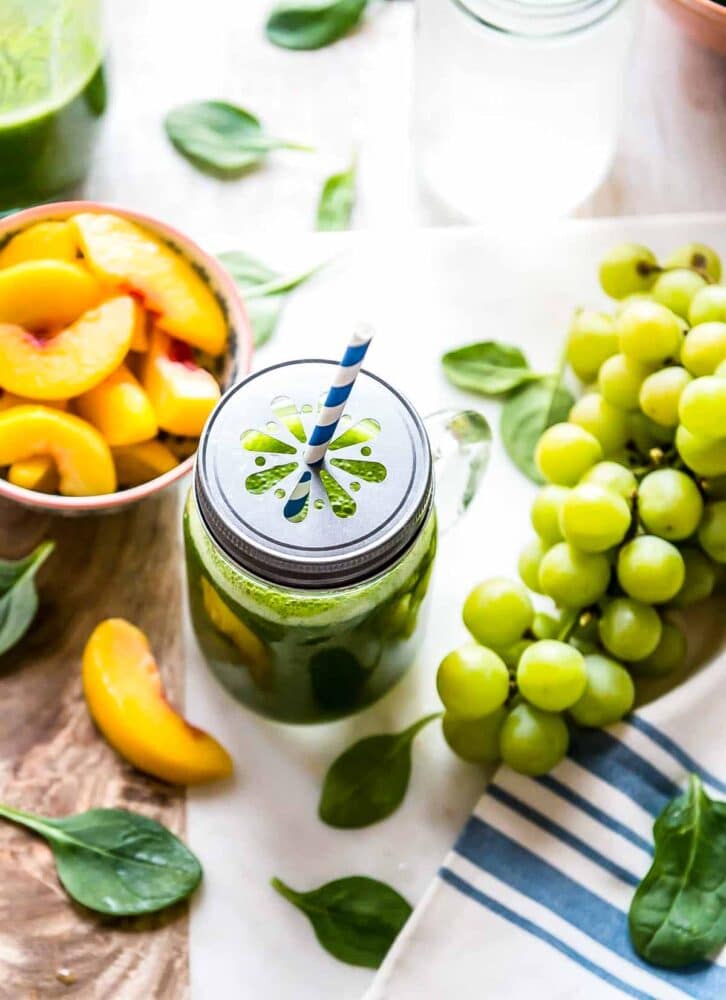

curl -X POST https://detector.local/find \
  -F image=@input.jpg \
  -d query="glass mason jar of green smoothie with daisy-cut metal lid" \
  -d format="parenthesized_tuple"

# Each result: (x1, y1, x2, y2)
(184, 361, 436, 722)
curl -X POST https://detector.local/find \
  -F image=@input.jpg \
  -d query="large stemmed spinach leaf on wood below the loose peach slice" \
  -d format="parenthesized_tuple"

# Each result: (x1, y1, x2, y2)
(0, 805, 202, 917)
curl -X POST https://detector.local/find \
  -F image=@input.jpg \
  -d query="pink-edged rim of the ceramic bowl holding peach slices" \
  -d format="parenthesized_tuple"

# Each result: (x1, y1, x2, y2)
(0, 201, 252, 515)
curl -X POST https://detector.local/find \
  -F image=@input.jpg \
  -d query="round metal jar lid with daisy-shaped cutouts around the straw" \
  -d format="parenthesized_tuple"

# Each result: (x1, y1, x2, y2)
(194, 360, 433, 590)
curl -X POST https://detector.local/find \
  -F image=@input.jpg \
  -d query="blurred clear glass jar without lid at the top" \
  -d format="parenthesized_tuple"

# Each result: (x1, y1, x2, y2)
(413, 0, 638, 220)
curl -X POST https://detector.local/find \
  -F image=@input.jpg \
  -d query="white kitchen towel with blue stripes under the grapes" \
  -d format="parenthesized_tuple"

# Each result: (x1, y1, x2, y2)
(366, 657, 726, 1000)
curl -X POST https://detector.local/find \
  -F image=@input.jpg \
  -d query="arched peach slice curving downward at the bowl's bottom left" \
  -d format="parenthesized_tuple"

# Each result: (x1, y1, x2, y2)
(0, 406, 116, 497)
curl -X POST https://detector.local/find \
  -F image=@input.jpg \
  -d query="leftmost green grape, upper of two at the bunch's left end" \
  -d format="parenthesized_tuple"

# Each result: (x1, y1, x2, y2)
(436, 642, 509, 719)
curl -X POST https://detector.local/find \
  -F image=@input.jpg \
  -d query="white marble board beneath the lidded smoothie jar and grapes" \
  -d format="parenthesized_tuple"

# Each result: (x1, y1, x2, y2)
(187, 216, 726, 1000)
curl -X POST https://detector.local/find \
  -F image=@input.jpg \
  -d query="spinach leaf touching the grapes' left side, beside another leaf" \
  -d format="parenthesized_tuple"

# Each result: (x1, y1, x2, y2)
(499, 376, 575, 483)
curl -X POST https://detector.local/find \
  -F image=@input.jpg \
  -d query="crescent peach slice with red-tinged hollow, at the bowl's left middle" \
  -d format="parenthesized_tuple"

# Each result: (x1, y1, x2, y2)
(0, 296, 134, 400)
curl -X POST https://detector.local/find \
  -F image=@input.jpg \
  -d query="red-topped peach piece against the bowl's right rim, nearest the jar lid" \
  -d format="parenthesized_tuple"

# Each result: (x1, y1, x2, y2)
(141, 330, 220, 437)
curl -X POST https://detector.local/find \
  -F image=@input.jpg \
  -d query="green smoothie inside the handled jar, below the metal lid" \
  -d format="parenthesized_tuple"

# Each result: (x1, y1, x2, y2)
(184, 491, 436, 722)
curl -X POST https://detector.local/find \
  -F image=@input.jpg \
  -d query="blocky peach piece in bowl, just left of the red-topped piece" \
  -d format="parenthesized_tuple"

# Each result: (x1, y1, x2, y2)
(75, 365, 159, 445)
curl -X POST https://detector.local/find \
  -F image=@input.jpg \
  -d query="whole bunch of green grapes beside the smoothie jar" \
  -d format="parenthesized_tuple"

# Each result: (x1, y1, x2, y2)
(437, 243, 726, 775)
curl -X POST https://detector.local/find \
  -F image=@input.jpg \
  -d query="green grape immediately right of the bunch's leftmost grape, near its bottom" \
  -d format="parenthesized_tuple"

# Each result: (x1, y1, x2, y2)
(517, 639, 587, 712)
